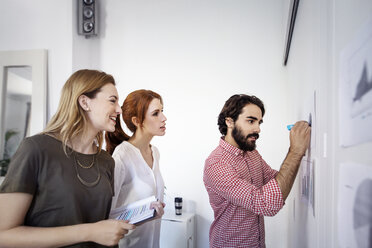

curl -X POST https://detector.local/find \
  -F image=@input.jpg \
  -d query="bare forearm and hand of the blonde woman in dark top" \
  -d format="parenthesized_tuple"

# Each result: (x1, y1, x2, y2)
(0, 193, 135, 248)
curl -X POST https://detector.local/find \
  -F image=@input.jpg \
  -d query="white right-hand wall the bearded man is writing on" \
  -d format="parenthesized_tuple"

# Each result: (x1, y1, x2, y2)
(285, 0, 372, 247)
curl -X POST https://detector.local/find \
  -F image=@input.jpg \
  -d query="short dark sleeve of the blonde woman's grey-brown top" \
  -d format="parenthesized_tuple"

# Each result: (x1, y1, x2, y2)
(0, 138, 41, 195)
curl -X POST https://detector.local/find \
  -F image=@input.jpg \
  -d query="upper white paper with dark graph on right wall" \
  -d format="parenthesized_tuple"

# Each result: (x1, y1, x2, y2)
(339, 17, 372, 147)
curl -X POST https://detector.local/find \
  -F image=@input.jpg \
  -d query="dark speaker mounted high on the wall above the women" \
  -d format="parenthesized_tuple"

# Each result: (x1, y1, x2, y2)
(77, 0, 98, 37)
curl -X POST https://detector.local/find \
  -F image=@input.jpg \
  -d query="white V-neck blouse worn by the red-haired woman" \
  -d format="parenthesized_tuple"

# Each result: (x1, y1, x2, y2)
(111, 141, 164, 248)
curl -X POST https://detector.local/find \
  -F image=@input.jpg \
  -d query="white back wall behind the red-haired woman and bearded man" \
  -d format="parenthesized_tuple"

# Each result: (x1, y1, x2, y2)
(99, 0, 288, 247)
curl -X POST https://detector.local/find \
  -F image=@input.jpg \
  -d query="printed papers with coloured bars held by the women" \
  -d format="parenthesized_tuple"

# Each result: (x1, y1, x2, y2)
(110, 196, 157, 224)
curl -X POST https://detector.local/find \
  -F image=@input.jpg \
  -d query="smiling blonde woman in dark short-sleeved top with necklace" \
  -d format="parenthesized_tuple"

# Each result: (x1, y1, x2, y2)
(0, 70, 135, 248)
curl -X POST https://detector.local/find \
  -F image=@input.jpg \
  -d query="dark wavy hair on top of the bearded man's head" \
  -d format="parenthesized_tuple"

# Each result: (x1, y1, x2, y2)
(217, 94, 265, 135)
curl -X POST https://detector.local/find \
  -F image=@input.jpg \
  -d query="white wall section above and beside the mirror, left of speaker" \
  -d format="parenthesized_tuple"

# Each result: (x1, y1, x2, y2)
(0, 0, 75, 120)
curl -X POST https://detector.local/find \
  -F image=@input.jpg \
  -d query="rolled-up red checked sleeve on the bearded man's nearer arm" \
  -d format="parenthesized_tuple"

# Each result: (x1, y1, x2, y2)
(204, 162, 283, 216)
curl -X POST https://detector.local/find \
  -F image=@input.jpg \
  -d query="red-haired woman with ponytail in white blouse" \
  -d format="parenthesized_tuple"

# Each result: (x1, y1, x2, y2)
(106, 90, 167, 248)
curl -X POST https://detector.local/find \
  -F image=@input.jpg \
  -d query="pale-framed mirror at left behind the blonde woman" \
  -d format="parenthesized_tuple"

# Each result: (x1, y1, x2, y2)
(0, 50, 47, 176)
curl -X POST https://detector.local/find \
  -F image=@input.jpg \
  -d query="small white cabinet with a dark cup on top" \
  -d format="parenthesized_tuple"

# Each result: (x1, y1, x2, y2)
(160, 211, 195, 248)
